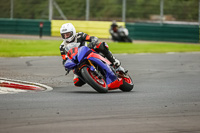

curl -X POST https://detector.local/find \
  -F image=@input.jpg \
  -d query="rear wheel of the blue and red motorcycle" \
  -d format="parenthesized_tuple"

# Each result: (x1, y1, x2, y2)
(119, 75, 134, 92)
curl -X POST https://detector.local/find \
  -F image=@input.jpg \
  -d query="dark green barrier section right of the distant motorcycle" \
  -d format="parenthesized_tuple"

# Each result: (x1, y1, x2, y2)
(126, 23, 199, 43)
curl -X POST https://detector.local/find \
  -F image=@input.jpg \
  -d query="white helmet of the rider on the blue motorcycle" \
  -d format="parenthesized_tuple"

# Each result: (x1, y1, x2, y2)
(60, 23, 76, 43)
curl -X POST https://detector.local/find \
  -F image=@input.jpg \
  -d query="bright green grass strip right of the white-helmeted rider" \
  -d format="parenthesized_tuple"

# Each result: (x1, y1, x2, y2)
(109, 42, 200, 54)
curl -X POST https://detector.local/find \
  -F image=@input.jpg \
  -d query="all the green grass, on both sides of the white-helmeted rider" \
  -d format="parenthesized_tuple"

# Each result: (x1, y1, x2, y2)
(0, 39, 200, 57)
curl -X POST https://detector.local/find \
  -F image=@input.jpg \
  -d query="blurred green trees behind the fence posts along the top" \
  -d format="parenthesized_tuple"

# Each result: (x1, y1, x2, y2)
(0, 0, 199, 22)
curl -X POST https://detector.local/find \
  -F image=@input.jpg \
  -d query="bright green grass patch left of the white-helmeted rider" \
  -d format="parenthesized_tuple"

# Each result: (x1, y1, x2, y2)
(0, 39, 62, 57)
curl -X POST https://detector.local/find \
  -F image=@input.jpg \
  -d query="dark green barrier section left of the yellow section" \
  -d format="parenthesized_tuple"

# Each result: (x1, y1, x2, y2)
(0, 19, 51, 36)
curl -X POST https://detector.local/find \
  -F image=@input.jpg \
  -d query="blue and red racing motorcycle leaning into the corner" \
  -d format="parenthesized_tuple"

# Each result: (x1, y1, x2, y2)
(65, 43, 134, 93)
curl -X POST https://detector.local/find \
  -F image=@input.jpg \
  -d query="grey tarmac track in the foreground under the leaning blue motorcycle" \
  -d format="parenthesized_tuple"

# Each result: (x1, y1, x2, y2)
(0, 53, 200, 133)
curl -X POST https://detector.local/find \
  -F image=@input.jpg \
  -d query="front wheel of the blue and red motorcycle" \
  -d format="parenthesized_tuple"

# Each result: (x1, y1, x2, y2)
(81, 67, 108, 93)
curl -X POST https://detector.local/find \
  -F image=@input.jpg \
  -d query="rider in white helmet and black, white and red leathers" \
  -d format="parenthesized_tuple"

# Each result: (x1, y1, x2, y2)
(60, 23, 121, 86)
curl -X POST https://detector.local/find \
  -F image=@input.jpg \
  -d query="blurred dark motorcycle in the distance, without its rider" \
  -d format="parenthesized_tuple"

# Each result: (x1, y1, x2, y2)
(110, 26, 132, 42)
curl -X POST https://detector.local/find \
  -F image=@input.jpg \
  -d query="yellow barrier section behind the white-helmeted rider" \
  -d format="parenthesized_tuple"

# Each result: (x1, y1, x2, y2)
(51, 20, 125, 38)
